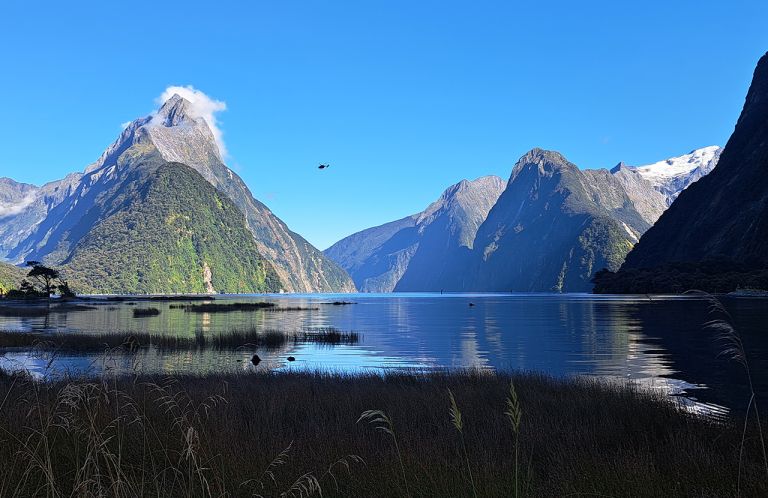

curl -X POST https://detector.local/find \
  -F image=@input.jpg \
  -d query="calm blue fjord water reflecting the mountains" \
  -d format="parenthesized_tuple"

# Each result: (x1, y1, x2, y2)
(0, 294, 768, 408)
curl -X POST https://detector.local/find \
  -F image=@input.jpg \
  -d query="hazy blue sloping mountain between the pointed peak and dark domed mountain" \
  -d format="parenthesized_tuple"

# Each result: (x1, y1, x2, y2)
(326, 176, 504, 292)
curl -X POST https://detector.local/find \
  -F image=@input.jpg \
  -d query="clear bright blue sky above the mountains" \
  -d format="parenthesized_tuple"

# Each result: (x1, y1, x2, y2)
(0, 0, 768, 249)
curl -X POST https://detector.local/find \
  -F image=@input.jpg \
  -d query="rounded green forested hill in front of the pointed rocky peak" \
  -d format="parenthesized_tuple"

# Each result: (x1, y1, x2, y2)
(64, 158, 281, 293)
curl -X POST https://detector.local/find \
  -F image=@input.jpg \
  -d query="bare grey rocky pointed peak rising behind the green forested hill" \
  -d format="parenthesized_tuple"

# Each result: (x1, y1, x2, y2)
(0, 95, 354, 292)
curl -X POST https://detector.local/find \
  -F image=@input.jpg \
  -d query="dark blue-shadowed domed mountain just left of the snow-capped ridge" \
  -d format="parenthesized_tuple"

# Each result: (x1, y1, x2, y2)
(463, 149, 649, 292)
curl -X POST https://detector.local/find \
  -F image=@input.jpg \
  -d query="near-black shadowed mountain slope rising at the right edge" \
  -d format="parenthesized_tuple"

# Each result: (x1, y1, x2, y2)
(623, 54, 768, 269)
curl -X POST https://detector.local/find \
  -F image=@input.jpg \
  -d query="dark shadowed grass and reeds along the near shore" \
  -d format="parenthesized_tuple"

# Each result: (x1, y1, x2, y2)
(0, 372, 768, 497)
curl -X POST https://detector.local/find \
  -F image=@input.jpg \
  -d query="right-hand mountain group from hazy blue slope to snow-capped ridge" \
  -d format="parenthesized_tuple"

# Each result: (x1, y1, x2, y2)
(326, 146, 720, 292)
